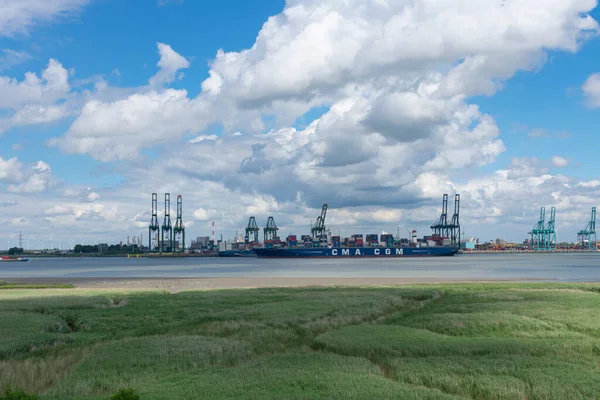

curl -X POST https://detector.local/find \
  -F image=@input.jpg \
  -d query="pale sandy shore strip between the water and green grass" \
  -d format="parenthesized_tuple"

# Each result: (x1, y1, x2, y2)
(0, 277, 551, 292)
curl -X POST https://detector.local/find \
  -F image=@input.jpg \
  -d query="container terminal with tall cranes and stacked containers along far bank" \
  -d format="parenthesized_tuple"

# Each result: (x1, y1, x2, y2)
(136, 193, 598, 257)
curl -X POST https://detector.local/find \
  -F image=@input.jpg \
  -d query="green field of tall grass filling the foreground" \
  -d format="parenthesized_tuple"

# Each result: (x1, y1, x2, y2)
(0, 284, 600, 400)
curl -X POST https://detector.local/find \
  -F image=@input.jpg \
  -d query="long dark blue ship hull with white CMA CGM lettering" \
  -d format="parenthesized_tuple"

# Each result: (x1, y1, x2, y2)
(253, 247, 458, 258)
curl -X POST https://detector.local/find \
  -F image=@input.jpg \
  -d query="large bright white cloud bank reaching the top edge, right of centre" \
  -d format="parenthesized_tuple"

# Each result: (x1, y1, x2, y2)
(203, 0, 597, 102)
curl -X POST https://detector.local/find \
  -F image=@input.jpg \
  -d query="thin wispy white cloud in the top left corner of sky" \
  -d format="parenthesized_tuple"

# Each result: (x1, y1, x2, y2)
(0, 0, 91, 36)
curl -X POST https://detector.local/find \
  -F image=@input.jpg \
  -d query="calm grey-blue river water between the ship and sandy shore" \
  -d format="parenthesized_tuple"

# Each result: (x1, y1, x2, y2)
(0, 253, 600, 281)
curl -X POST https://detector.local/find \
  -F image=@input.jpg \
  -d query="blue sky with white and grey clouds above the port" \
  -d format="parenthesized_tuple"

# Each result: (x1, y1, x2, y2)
(0, 0, 600, 249)
